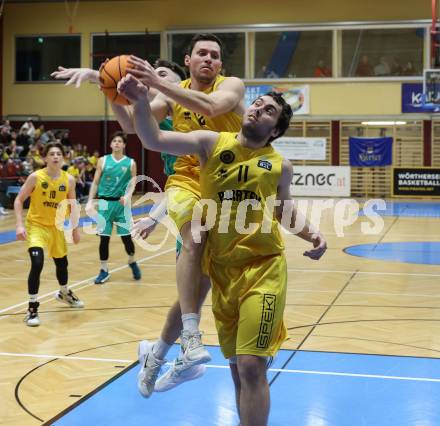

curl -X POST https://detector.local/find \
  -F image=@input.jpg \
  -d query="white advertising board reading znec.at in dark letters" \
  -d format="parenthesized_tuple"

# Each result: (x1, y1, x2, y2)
(290, 166, 351, 197)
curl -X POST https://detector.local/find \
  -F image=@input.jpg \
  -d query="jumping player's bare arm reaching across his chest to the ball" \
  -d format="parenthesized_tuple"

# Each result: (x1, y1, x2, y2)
(127, 56, 244, 117)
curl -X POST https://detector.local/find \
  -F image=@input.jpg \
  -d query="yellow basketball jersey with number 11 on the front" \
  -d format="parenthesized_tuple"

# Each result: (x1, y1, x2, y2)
(200, 132, 284, 264)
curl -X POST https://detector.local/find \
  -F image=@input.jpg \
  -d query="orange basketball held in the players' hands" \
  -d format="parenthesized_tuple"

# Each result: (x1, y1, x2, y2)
(99, 55, 130, 105)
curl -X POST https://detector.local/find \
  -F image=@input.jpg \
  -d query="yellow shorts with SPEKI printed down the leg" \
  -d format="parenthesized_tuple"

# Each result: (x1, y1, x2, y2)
(209, 254, 287, 358)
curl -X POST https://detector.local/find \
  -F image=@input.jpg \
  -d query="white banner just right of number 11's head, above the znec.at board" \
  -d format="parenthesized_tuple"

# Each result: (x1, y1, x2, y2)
(272, 136, 327, 160)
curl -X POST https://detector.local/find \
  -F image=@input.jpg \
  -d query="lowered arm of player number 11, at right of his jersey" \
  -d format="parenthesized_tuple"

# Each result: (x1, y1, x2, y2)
(276, 160, 327, 260)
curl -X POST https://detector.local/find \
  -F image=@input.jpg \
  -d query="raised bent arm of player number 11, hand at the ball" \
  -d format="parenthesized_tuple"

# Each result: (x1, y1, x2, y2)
(118, 75, 218, 161)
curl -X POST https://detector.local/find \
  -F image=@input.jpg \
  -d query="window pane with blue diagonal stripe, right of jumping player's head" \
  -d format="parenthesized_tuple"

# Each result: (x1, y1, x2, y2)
(254, 31, 332, 78)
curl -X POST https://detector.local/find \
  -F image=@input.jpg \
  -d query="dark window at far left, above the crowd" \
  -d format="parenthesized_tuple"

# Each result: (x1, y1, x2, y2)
(15, 35, 81, 82)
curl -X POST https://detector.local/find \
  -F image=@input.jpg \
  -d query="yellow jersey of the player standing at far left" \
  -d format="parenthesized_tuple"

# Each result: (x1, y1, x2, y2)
(26, 168, 69, 226)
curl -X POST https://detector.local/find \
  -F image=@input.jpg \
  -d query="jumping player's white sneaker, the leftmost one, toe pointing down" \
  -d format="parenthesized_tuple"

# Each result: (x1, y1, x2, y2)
(137, 340, 166, 398)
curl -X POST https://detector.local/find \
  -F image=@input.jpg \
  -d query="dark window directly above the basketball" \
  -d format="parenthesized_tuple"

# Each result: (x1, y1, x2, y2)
(92, 33, 160, 70)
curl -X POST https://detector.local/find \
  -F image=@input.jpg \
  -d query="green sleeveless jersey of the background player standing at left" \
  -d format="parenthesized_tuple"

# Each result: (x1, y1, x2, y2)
(98, 154, 133, 198)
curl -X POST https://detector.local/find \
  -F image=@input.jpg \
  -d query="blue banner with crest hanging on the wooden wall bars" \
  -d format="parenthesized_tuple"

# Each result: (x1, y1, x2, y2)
(348, 137, 393, 167)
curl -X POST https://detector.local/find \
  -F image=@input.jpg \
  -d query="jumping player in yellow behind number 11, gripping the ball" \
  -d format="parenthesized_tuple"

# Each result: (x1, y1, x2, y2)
(52, 34, 244, 397)
